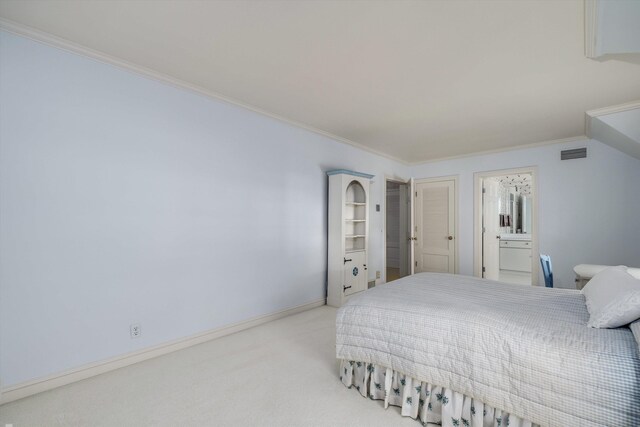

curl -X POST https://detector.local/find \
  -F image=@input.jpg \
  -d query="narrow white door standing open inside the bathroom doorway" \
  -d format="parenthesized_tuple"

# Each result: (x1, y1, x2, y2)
(482, 178, 500, 280)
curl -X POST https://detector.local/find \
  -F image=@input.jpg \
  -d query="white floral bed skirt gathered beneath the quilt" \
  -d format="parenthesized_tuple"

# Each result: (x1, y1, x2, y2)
(340, 360, 537, 427)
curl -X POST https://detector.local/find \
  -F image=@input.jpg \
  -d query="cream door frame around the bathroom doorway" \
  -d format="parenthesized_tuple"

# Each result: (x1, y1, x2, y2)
(473, 166, 540, 286)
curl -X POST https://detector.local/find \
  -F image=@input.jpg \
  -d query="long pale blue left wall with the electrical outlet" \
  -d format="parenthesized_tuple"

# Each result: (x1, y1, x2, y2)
(0, 32, 407, 387)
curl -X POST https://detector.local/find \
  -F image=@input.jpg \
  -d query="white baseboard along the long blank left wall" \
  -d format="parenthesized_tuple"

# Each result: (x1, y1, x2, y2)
(0, 298, 326, 405)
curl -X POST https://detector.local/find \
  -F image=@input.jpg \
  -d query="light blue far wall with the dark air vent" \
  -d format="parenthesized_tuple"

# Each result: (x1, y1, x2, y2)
(410, 140, 640, 289)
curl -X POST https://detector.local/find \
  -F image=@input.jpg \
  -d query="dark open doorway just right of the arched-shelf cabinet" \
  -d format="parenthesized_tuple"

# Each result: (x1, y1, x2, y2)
(385, 179, 411, 282)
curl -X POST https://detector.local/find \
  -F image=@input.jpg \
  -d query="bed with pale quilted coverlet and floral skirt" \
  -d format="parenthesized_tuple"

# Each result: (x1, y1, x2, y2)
(336, 273, 640, 427)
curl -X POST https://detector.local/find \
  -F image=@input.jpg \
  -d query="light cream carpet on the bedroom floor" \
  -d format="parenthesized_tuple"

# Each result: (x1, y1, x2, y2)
(0, 306, 420, 427)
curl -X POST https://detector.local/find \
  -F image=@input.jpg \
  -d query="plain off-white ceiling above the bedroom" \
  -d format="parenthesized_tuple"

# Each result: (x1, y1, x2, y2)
(0, 0, 640, 163)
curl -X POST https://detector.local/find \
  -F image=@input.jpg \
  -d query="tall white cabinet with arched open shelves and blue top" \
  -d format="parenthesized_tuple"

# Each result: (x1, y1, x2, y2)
(327, 170, 373, 307)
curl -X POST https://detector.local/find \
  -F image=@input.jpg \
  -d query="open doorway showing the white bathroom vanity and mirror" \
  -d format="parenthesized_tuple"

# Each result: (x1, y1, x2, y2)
(475, 168, 539, 285)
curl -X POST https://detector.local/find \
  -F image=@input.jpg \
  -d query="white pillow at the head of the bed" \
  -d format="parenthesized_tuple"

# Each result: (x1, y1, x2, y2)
(582, 265, 640, 328)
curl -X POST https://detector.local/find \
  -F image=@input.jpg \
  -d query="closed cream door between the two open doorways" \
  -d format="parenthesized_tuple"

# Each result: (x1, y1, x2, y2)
(415, 179, 455, 273)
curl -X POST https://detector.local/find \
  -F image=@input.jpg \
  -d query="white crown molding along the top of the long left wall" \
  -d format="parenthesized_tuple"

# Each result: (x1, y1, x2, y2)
(0, 18, 408, 165)
